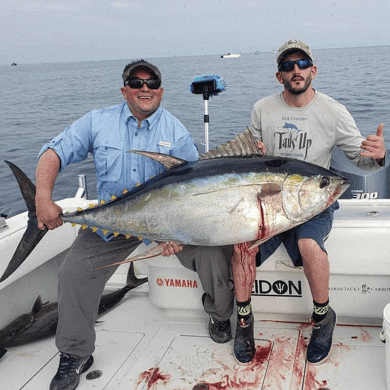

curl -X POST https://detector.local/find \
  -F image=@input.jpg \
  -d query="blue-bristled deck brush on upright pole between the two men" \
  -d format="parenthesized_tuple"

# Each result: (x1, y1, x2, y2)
(190, 74, 226, 153)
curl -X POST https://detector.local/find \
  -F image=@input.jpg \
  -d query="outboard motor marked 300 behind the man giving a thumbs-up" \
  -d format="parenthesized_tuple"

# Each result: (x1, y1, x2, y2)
(330, 147, 390, 199)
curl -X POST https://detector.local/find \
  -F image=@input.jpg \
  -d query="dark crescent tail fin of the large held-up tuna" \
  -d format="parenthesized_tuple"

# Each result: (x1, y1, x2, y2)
(0, 161, 48, 283)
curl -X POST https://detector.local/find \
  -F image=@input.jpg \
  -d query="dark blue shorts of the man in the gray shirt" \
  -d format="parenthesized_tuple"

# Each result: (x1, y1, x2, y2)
(256, 202, 340, 267)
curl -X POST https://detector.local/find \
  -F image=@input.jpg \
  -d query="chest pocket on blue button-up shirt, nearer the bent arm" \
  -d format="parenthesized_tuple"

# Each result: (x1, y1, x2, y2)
(94, 145, 123, 183)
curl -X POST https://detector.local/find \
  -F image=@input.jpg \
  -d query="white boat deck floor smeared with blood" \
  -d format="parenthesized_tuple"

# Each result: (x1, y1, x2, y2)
(0, 285, 386, 390)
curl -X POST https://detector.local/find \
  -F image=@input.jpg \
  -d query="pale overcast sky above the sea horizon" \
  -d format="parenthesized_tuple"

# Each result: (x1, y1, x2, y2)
(0, 0, 390, 64)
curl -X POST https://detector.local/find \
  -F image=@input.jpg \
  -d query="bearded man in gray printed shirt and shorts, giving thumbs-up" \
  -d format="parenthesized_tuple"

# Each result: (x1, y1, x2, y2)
(232, 39, 386, 364)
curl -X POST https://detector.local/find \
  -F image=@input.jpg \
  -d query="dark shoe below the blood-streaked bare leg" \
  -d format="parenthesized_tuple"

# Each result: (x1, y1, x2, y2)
(233, 315, 256, 364)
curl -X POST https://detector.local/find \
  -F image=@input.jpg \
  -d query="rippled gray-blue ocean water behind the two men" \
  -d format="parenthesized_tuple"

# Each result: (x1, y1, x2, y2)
(0, 46, 390, 216)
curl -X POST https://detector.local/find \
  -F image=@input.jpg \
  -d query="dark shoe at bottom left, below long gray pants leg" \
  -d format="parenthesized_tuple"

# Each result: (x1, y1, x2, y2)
(50, 352, 93, 390)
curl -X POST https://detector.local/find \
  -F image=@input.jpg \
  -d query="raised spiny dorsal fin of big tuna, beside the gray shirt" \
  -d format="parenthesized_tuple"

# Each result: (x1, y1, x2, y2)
(199, 127, 262, 160)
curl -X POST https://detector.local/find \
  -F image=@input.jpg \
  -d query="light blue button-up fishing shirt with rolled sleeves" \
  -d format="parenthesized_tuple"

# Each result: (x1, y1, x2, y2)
(39, 102, 198, 239)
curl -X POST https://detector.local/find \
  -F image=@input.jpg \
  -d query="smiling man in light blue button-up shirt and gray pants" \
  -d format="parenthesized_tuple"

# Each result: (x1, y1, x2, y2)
(35, 60, 233, 390)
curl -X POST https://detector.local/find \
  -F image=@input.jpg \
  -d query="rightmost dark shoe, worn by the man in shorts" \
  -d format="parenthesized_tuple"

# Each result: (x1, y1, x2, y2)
(306, 307, 336, 365)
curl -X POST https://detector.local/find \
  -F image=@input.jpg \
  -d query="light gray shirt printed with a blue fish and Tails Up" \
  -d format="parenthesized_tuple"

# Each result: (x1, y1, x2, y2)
(251, 91, 379, 170)
